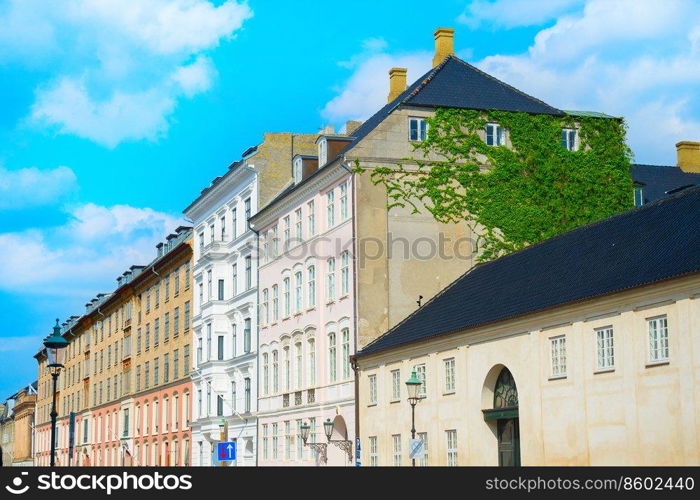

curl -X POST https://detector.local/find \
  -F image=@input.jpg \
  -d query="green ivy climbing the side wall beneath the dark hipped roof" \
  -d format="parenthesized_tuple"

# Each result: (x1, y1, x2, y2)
(360, 109, 633, 261)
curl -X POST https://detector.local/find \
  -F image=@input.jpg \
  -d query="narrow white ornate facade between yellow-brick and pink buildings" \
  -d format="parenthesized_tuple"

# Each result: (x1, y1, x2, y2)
(185, 158, 258, 466)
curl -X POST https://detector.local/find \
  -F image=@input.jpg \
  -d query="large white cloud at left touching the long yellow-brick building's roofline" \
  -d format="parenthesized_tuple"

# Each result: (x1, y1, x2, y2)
(0, 204, 182, 301)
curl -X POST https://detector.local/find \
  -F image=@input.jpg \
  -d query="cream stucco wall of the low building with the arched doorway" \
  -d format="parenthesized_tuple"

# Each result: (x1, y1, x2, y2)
(359, 276, 700, 465)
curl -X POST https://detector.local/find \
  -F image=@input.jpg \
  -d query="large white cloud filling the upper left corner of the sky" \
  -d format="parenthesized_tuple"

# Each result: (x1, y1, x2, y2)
(0, 0, 252, 147)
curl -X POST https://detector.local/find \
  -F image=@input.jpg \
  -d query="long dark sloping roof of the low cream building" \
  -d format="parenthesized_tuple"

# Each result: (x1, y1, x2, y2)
(358, 187, 700, 356)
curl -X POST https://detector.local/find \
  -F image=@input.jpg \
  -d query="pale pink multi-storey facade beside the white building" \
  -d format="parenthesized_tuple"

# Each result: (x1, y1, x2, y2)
(255, 153, 355, 466)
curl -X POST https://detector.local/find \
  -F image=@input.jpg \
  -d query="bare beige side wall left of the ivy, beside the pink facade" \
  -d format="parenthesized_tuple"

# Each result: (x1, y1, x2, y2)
(347, 108, 474, 348)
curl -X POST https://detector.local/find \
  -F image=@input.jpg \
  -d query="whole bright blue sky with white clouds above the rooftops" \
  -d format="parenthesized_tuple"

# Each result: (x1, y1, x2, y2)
(0, 0, 700, 398)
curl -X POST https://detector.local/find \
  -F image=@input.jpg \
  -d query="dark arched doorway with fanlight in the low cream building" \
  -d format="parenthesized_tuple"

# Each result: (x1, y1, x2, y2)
(483, 367, 520, 467)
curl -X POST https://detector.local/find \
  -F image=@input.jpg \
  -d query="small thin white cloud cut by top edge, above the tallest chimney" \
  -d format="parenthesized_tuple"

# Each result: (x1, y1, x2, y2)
(457, 0, 583, 28)
